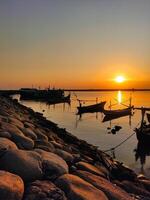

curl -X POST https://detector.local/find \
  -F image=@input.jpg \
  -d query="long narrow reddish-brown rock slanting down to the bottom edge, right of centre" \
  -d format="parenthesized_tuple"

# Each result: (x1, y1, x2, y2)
(75, 171, 133, 200)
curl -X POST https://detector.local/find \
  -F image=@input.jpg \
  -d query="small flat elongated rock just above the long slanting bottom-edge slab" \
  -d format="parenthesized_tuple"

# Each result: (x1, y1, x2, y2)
(76, 161, 106, 177)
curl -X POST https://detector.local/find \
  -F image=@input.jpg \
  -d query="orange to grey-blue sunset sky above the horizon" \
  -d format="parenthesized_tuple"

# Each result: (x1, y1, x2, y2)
(0, 0, 150, 89)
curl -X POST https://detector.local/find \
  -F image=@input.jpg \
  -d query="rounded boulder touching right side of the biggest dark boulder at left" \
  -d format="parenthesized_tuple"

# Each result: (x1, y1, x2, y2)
(36, 149, 68, 179)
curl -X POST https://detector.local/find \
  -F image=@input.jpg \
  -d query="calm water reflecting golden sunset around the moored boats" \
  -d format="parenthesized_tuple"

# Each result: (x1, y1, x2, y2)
(15, 91, 150, 176)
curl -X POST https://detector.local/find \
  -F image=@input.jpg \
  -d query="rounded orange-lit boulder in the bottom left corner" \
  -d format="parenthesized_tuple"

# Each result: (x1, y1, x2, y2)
(0, 171, 24, 200)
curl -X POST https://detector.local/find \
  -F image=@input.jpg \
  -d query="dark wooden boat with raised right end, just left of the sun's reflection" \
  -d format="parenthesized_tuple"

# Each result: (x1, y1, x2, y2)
(77, 101, 106, 114)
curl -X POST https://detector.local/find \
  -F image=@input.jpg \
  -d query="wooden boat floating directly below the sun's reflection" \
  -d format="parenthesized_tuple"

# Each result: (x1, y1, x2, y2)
(103, 107, 133, 117)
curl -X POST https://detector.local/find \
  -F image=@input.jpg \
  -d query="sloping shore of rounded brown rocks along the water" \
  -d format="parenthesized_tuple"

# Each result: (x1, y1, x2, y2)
(0, 96, 150, 200)
